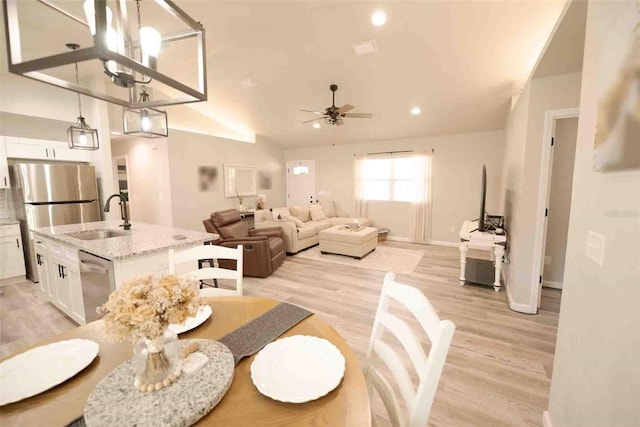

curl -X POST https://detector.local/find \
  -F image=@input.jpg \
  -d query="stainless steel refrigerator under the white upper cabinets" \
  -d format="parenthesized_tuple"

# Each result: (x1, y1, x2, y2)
(9, 163, 100, 282)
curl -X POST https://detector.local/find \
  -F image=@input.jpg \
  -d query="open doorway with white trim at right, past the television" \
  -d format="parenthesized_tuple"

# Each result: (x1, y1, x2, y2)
(532, 109, 578, 307)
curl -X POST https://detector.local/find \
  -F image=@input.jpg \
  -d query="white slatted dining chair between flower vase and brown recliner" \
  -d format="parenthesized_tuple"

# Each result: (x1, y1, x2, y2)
(169, 245, 244, 297)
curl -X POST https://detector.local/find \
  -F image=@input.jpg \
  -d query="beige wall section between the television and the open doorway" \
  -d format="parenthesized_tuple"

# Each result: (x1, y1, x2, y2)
(502, 73, 581, 312)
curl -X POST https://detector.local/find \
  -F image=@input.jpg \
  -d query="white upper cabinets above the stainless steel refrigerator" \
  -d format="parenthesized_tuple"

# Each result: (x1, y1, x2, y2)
(3, 136, 89, 162)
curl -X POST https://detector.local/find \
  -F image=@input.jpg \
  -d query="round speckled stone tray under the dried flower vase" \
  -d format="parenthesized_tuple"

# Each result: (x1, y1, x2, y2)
(84, 339, 235, 427)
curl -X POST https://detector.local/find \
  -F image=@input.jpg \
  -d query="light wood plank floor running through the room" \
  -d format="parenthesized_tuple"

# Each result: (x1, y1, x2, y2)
(0, 242, 561, 426)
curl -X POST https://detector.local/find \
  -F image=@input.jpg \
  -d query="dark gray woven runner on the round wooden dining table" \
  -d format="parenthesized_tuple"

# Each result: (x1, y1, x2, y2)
(218, 302, 313, 365)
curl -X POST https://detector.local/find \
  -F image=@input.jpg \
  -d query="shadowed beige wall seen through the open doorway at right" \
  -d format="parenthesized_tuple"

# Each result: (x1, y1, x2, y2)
(543, 117, 578, 287)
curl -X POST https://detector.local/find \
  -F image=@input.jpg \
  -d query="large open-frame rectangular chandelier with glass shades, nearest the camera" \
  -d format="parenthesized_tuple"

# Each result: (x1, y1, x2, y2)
(2, 0, 207, 109)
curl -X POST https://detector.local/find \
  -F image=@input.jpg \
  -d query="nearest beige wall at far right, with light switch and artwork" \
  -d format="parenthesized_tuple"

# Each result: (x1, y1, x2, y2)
(549, 1, 640, 426)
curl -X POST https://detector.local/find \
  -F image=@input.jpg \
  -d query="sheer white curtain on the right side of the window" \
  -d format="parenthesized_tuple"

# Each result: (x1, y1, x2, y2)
(409, 153, 431, 243)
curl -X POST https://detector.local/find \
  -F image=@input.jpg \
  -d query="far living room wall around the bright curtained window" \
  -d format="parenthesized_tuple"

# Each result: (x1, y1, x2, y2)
(284, 129, 504, 242)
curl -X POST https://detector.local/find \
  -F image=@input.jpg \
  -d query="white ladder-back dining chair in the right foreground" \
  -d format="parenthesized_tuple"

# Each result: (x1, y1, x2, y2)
(365, 273, 455, 427)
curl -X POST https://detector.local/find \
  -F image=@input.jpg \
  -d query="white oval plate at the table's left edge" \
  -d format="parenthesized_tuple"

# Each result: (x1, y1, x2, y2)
(0, 339, 100, 406)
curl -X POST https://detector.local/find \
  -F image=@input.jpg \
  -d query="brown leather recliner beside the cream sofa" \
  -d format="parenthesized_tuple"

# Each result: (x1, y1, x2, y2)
(202, 209, 286, 277)
